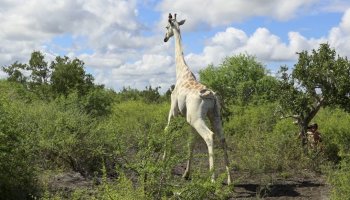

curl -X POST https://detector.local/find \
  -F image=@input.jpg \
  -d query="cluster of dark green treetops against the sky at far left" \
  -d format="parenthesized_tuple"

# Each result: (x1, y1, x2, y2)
(2, 51, 102, 101)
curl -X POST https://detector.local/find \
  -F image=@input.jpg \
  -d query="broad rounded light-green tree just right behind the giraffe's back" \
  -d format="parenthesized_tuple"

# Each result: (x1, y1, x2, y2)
(199, 54, 278, 116)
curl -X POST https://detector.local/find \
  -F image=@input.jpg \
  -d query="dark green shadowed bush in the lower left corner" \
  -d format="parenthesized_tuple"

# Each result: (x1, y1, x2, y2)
(0, 88, 37, 199)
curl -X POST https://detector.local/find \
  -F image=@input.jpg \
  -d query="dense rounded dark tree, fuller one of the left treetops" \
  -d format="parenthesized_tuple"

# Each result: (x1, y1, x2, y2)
(51, 56, 94, 96)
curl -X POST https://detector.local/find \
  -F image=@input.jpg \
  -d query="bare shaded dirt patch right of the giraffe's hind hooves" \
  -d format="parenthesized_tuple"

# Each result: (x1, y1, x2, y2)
(231, 173, 330, 200)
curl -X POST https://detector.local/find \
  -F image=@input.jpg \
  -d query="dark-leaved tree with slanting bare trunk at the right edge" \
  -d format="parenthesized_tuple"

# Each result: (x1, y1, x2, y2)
(279, 44, 350, 144)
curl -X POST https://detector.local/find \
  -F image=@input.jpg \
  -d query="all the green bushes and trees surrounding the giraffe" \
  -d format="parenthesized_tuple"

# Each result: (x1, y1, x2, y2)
(0, 44, 350, 199)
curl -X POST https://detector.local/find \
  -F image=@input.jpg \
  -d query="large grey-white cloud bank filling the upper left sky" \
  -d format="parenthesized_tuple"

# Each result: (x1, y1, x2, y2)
(0, 0, 144, 64)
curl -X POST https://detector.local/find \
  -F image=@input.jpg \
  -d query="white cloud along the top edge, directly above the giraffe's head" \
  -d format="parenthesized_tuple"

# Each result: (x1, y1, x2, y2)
(158, 0, 317, 28)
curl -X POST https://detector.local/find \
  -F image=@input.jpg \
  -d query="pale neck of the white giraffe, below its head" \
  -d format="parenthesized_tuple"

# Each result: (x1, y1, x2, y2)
(174, 29, 192, 80)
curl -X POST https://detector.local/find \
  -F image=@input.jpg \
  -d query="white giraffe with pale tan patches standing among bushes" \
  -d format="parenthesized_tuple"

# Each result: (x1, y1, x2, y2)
(164, 14, 231, 184)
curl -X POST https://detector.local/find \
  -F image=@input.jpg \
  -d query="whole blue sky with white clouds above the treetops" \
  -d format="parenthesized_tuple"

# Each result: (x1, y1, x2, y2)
(0, 0, 350, 91)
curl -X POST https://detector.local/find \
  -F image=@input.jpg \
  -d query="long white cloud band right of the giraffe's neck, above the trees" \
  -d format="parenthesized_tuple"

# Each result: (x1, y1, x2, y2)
(186, 6, 350, 72)
